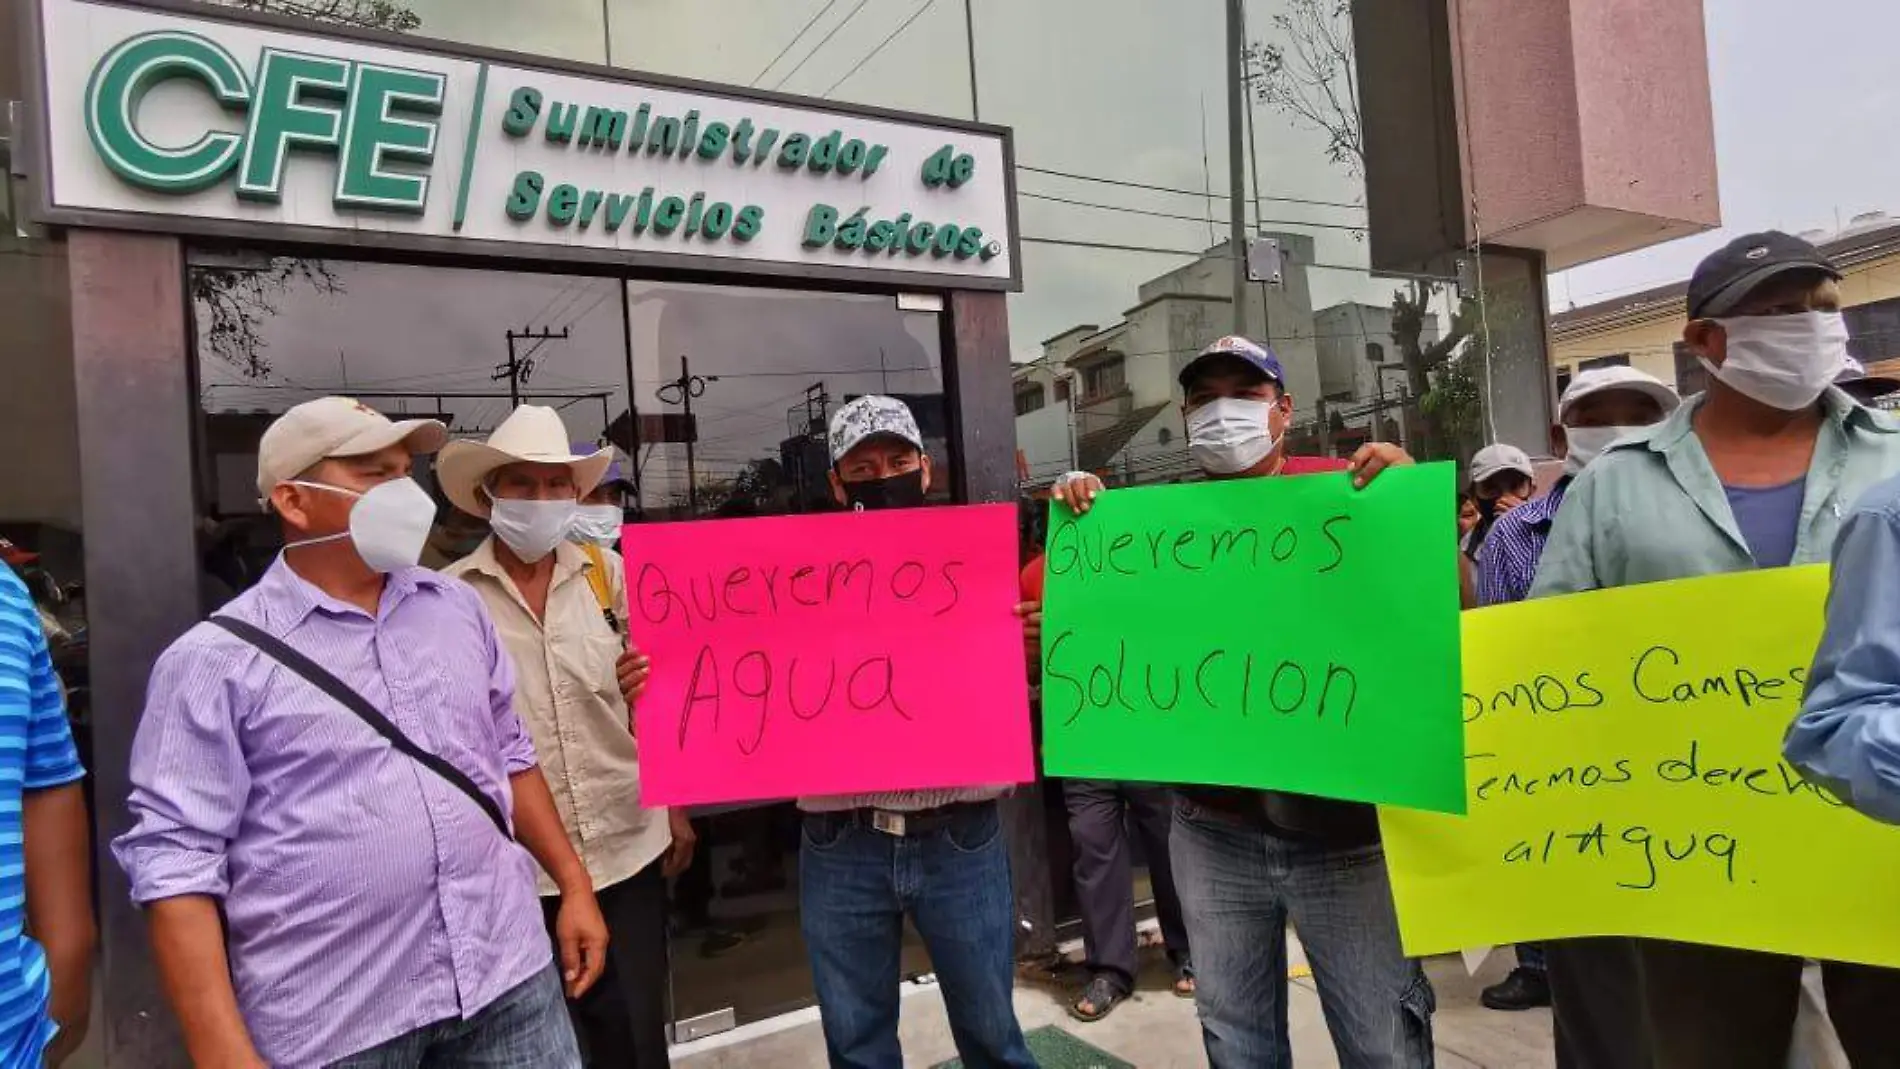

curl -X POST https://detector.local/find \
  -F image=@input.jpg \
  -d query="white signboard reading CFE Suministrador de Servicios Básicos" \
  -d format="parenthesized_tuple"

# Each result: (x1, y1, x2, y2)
(26, 0, 1020, 289)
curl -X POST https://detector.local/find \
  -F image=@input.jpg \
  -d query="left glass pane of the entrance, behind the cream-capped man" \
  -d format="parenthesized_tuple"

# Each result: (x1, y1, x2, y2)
(188, 251, 629, 591)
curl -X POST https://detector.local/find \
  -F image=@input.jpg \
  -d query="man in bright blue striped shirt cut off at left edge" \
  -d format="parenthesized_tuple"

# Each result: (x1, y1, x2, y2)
(0, 568, 93, 1069)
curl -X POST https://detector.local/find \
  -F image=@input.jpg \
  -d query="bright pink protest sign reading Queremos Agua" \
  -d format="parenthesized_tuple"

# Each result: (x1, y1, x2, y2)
(621, 505, 1036, 805)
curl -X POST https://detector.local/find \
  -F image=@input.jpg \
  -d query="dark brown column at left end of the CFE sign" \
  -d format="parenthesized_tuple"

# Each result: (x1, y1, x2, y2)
(67, 230, 200, 1069)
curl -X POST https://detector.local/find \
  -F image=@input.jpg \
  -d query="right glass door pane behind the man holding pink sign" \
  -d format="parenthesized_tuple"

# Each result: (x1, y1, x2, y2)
(627, 281, 954, 1041)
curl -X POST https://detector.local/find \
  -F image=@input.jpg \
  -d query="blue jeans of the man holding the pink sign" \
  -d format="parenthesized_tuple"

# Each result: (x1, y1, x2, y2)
(798, 803, 1036, 1069)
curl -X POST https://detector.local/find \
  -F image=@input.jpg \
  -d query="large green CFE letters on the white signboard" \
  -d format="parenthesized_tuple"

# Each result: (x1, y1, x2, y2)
(86, 30, 448, 215)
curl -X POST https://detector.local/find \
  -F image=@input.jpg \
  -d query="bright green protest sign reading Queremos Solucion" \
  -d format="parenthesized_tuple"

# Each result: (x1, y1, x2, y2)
(1043, 463, 1465, 813)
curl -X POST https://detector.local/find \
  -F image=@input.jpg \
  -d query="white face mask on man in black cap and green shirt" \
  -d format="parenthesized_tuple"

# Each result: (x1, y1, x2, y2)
(1699, 311, 1847, 412)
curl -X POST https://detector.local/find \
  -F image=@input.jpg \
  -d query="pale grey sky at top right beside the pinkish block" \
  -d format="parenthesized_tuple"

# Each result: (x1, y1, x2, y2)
(1550, 0, 1900, 311)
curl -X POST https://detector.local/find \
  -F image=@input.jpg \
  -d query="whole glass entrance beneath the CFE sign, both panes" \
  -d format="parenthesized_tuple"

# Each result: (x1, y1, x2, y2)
(188, 249, 956, 1022)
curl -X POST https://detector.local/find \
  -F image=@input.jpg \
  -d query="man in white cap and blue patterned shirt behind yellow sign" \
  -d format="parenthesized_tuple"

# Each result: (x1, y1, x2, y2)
(1478, 366, 1680, 1010)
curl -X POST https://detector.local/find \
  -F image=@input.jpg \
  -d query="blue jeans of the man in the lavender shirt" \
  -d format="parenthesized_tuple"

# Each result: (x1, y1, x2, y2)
(331, 965, 581, 1069)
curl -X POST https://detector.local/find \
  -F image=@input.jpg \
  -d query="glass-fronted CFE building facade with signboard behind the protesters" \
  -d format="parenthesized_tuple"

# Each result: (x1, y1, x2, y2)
(0, 0, 1714, 1067)
